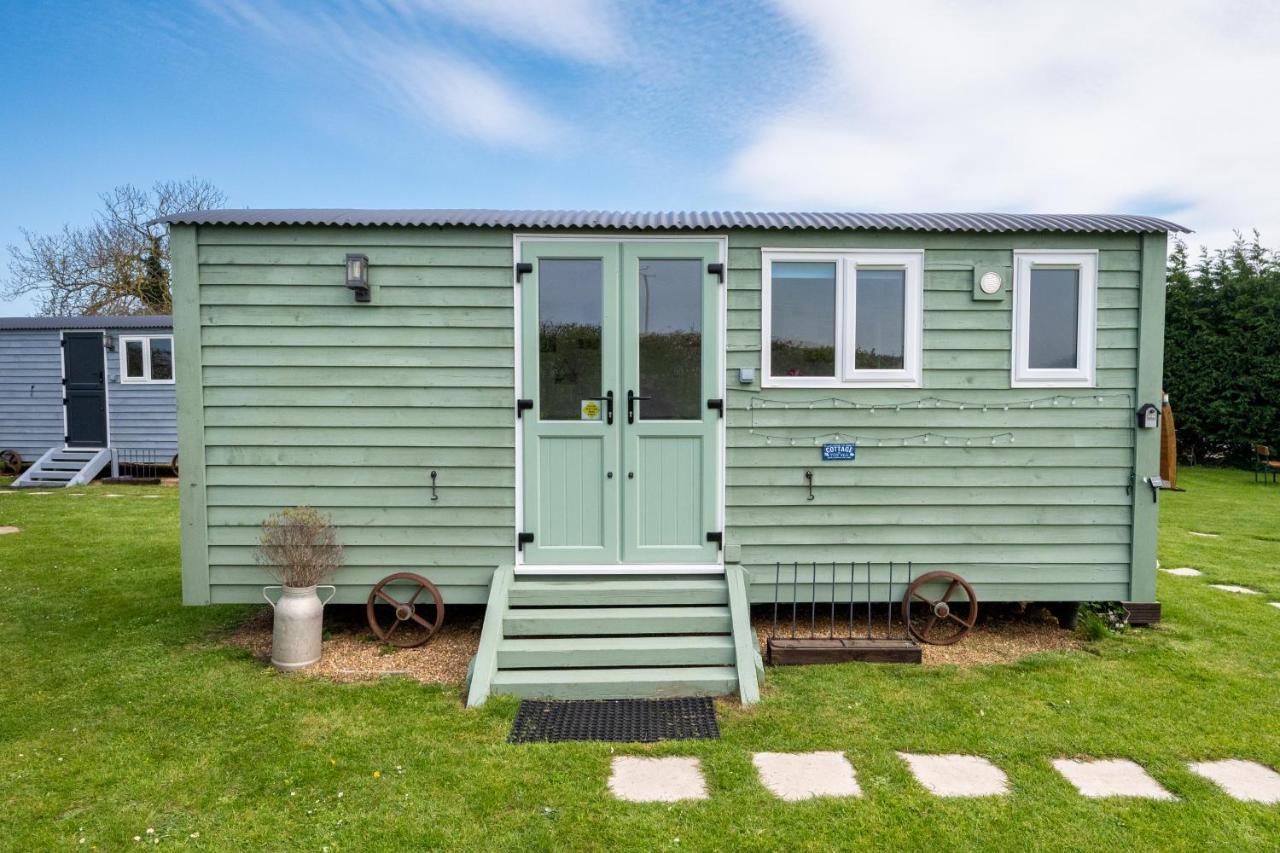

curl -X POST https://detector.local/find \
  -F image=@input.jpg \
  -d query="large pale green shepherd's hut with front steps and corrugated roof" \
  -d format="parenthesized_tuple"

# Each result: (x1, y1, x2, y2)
(166, 210, 1180, 702)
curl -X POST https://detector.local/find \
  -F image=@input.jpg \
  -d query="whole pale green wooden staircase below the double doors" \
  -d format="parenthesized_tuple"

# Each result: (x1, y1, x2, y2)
(467, 566, 760, 706)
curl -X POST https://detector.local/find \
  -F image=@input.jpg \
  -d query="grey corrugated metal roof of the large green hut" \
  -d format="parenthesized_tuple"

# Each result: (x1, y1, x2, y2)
(156, 209, 1190, 233)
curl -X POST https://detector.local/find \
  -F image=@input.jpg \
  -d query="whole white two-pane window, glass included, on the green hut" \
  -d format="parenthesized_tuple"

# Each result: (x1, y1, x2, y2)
(760, 250, 923, 388)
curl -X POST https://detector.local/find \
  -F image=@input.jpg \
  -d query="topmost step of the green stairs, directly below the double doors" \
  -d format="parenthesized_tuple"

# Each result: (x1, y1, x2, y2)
(508, 578, 728, 607)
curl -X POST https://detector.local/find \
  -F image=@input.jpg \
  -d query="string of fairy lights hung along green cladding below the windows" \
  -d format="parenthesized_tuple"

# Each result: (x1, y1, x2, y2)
(748, 393, 1133, 447)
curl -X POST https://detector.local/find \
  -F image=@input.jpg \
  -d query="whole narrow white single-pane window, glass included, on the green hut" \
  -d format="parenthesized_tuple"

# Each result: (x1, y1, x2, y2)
(1010, 251, 1098, 388)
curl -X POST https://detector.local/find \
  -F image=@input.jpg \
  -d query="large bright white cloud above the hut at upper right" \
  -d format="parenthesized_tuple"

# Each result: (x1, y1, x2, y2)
(724, 0, 1280, 243)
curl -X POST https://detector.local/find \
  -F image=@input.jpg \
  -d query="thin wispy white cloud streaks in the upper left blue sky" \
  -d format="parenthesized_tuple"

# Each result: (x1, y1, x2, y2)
(205, 0, 621, 150)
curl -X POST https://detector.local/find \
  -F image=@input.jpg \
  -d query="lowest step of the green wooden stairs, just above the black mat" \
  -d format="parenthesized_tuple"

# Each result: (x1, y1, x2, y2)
(493, 666, 737, 699)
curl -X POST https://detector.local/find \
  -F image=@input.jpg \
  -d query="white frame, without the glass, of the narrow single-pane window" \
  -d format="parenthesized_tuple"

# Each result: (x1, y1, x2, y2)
(1009, 250, 1098, 388)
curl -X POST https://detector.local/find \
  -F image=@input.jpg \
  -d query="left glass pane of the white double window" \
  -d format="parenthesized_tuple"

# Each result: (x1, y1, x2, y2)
(769, 261, 836, 377)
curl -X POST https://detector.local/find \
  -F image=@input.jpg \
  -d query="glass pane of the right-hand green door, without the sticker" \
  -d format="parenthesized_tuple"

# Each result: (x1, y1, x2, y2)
(636, 259, 703, 420)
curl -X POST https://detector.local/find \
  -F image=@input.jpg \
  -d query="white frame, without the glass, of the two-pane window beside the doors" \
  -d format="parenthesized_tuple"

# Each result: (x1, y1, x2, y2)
(760, 248, 924, 388)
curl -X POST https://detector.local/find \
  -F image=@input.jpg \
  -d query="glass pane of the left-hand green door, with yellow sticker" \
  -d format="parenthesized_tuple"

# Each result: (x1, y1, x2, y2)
(538, 259, 604, 420)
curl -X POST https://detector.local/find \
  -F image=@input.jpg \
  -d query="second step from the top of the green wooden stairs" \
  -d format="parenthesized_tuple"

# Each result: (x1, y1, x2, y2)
(503, 607, 733, 637)
